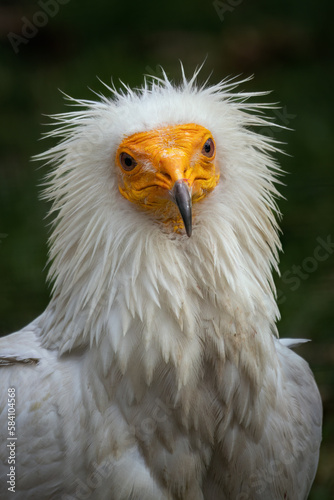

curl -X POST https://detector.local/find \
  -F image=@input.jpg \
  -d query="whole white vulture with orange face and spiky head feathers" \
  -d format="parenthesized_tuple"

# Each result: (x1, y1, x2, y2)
(0, 68, 322, 500)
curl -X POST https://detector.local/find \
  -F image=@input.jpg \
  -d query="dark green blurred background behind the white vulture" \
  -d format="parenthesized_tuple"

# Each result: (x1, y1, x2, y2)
(0, 0, 334, 500)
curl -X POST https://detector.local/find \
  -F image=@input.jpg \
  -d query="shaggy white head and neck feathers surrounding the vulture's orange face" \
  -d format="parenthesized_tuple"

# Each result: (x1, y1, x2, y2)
(37, 68, 280, 390)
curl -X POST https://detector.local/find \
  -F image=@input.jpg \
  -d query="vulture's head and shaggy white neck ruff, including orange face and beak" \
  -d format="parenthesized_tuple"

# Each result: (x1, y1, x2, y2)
(39, 66, 279, 381)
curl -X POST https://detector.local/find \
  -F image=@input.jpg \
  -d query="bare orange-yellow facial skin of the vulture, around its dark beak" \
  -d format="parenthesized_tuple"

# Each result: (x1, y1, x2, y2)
(116, 123, 219, 235)
